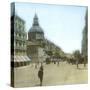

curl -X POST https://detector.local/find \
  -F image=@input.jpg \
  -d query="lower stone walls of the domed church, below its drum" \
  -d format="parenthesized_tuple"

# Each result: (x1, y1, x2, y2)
(27, 41, 45, 63)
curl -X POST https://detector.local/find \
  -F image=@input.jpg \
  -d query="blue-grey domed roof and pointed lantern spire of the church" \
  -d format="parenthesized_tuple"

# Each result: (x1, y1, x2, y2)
(29, 14, 44, 33)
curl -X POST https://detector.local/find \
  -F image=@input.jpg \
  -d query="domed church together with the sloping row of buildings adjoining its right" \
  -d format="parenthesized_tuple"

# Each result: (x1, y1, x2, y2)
(27, 14, 63, 62)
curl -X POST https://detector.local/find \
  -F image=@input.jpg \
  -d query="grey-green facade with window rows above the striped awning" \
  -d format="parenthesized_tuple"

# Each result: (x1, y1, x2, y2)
(14, 16, 27, 55)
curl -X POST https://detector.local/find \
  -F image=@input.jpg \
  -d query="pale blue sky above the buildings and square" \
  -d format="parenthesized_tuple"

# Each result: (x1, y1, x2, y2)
(12, 3, 86, 53)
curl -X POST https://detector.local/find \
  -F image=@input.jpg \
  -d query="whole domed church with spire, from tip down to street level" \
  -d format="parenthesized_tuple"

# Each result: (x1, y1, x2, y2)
(27, 14, 45, 63)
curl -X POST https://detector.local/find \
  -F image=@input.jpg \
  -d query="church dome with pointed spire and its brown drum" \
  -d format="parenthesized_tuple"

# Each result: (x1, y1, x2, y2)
(28, 14, 44, 42)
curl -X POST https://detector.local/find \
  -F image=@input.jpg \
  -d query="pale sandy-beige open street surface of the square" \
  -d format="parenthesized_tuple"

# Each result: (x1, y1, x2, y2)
(14, 62, 88, 87)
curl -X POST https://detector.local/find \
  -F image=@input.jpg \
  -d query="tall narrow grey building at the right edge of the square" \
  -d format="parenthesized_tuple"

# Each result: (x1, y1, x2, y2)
(82, 10, 88, 57)
